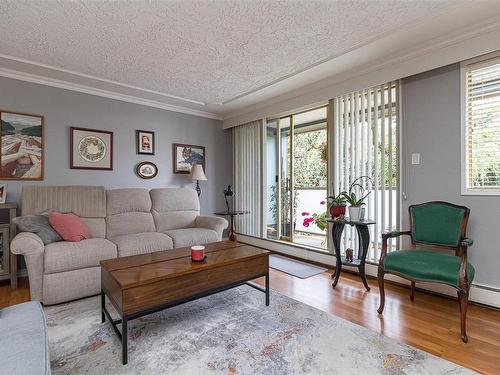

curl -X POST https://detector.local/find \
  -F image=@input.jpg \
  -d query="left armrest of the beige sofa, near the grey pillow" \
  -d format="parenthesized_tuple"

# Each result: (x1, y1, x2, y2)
(10, 232, 45, 301)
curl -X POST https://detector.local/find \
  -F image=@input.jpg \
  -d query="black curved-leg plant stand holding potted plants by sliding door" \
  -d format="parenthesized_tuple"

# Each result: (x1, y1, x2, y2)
(327, 219, 375, 291)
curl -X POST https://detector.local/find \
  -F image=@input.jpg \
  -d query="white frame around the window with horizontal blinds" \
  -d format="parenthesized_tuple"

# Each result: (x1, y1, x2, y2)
(460, 51, 500, 196)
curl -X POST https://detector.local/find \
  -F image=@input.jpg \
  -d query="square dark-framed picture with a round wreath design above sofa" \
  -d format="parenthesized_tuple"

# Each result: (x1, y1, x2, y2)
(70, 127, 113, 171)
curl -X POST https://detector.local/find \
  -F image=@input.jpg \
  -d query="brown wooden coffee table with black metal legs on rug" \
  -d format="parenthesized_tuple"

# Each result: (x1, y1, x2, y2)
(101, 241, 269, 365)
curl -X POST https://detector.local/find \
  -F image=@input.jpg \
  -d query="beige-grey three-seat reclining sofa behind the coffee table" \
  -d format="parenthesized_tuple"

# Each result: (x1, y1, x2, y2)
(11, 186, 228, 305)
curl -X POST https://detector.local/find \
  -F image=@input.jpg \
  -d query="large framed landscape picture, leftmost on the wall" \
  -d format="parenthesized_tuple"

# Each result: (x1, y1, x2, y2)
(0, 111, 44, 180)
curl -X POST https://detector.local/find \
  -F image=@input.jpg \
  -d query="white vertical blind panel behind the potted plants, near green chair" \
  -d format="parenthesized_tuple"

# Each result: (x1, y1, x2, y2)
(330, 82, 400, 262)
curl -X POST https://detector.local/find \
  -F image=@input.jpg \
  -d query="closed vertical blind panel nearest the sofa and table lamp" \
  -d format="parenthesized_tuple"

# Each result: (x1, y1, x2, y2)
(233, 121, 262, 237)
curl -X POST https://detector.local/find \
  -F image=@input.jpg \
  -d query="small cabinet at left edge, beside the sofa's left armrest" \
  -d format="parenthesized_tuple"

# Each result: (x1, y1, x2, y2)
(0, 203, 17, 289)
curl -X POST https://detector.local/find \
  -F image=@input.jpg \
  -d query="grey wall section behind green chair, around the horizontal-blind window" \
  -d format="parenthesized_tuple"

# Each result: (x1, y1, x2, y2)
(402, 64, 500, 288)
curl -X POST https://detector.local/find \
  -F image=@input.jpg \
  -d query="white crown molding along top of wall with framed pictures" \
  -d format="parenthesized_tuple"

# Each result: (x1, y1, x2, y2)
(0, 67, 222, 120)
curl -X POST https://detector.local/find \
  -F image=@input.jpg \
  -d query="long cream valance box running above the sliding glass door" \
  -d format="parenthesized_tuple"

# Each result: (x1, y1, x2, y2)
(223, 11, 500, 129)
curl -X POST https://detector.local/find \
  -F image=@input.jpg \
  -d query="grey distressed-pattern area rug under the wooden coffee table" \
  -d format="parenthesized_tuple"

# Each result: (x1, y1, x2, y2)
(45, 286, 472, 375)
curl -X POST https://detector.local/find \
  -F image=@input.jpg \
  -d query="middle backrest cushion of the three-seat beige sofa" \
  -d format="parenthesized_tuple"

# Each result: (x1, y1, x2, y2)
(106, 189, 156, 239)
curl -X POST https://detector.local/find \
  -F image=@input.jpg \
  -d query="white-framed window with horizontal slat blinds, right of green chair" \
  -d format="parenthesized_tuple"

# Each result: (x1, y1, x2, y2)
(461, 53, 500, 195)
